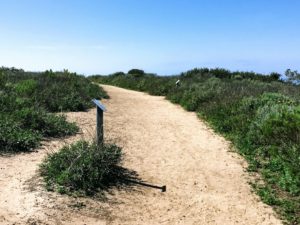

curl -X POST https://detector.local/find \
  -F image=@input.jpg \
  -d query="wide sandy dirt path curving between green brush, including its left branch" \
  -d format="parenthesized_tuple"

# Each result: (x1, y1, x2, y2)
(0, 86, 281, 225)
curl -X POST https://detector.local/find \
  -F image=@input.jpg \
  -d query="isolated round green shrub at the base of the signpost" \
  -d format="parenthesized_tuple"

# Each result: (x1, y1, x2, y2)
(40, 141, 122, 194)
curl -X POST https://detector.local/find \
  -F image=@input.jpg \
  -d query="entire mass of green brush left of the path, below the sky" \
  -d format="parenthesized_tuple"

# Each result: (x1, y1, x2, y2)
(0, 67, 107, 152)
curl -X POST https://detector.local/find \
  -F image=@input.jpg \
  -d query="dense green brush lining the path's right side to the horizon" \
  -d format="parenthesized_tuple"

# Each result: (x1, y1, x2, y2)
(90, 68, 300, 224)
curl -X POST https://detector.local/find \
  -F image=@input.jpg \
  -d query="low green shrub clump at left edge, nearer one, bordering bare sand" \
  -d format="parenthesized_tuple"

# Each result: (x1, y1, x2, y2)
(0, 108, 79, 152)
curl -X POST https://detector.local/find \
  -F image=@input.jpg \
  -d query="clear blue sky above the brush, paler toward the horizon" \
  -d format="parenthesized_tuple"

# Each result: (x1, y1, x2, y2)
(0, 0, 300, 75)
